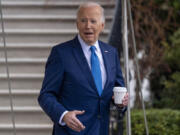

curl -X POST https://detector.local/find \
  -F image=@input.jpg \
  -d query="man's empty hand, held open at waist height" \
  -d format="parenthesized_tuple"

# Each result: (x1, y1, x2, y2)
(62, 110, 85, 132)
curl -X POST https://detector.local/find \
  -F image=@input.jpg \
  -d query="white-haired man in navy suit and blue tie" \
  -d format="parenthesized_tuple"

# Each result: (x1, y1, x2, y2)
(38, 2, 128, 135)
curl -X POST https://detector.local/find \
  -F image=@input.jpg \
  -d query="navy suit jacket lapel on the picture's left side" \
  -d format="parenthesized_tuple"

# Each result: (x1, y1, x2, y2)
(73, 36, 98, 94)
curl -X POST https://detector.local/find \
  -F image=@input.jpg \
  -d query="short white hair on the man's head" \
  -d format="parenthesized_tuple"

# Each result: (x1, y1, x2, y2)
(77, 2, 105, 23)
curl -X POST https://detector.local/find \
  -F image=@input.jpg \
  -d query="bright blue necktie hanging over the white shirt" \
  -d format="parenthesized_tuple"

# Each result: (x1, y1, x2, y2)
(90, 46, 102, 96)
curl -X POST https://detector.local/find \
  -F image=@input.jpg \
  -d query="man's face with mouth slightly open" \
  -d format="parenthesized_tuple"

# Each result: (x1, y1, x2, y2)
(77, 6, 104, 45)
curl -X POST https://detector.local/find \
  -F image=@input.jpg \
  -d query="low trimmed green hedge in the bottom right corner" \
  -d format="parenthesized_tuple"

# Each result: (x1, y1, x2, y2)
(124, 109, 180, 135)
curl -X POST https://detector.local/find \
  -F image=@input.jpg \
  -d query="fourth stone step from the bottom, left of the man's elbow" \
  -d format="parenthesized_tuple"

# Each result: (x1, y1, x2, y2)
(0, 73, 44, 89)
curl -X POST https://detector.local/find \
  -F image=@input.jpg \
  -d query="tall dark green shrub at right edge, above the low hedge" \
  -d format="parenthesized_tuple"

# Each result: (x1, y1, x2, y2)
(150, 28, 180, 109)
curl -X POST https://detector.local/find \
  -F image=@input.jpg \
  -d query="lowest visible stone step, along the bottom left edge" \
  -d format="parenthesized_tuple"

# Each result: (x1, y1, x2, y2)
(0, 124, 52, 135)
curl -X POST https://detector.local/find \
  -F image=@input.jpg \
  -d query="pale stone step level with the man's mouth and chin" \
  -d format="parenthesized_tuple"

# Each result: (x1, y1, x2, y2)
(0, 29, 109, 44)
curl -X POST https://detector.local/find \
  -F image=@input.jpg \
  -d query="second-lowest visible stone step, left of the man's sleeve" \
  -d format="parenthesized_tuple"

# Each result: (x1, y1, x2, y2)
(0, 106, 52, 125)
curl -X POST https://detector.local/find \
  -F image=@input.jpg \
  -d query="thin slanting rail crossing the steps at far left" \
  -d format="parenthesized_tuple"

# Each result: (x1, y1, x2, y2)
(0, 0, 16, 135)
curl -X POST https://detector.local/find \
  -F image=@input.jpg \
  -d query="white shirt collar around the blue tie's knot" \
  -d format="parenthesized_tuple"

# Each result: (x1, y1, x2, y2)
(78, 34, 100, 52)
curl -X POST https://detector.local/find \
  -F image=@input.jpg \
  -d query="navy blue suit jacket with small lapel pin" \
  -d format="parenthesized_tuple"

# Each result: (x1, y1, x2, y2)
(38, 36, 124, 135)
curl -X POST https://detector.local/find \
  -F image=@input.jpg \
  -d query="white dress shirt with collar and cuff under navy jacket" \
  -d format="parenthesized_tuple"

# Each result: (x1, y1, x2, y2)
(59, 34, 106, 126)
